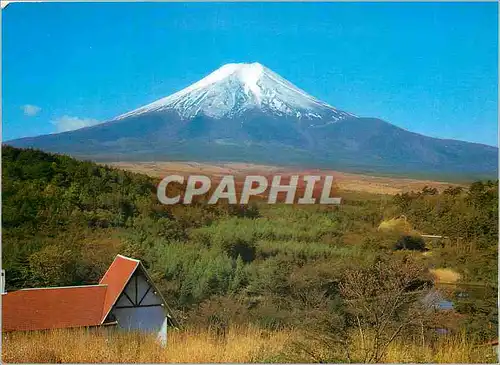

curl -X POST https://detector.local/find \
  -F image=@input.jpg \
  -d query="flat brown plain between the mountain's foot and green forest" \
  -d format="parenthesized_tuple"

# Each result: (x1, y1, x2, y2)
(107, 161, 465, 195)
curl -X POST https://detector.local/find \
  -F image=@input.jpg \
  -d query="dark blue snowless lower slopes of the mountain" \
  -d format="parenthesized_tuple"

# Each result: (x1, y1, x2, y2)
(7, 113, 498, 181)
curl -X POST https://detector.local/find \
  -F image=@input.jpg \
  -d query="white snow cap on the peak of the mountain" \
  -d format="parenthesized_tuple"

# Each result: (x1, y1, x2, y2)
(115, 62, 352, 120)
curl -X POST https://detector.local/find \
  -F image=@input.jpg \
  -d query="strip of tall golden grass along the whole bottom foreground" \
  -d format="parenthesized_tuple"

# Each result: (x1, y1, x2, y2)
(2, 326, 497, 363)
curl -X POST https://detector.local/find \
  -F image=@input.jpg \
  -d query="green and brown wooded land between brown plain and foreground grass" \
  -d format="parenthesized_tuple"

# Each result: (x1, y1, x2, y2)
(2, 146, 498, 362)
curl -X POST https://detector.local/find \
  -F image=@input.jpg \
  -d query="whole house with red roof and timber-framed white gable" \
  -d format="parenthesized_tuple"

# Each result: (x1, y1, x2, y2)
(2, 255, 177, 341)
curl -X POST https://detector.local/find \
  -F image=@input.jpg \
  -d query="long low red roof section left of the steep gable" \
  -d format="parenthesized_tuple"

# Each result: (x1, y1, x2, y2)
(2, 285, 106, 331)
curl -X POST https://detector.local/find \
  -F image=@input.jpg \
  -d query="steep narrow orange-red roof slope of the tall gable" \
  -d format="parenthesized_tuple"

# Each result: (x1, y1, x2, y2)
(99, 255, 140, 322)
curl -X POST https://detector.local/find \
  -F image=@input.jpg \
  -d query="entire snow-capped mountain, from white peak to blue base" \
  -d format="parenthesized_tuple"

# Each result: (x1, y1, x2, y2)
(6, 63, 498, 177)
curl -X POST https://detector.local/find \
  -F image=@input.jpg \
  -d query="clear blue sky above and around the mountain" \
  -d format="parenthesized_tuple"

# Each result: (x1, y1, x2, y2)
(2, 2, 498, 145)
